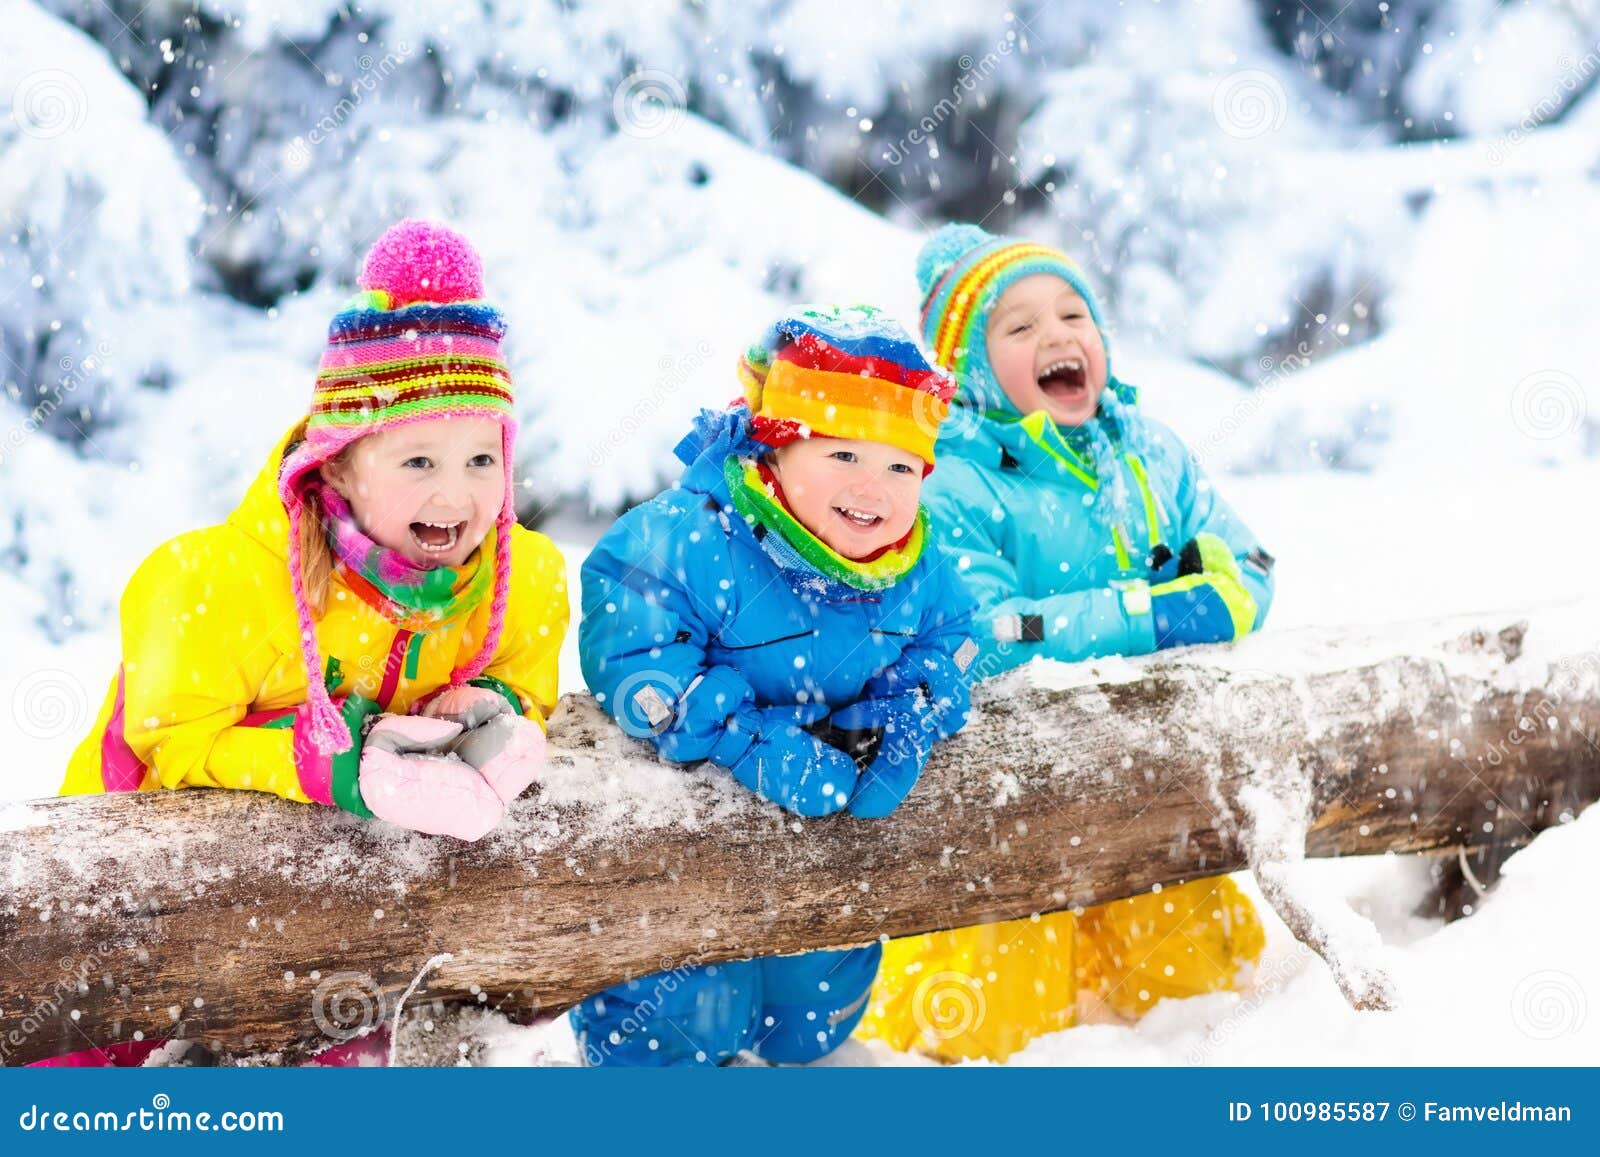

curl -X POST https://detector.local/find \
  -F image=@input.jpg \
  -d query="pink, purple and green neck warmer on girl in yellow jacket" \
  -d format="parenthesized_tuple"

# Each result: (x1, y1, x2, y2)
(306, 482, 496, 634)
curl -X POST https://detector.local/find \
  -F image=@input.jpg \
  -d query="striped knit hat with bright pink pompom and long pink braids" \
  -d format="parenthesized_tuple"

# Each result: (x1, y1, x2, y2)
(278, 219, 517, 755)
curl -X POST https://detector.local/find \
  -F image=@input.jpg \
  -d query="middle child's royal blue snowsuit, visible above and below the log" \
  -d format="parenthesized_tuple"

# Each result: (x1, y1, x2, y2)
(571, 406, 976, 1066)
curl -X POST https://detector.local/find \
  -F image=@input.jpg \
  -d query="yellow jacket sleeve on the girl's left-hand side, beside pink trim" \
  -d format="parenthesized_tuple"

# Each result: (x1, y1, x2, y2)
(122, 530, 321, 803)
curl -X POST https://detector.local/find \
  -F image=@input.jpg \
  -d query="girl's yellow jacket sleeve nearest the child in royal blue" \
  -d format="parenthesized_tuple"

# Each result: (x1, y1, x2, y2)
(472, 526, 571, 725)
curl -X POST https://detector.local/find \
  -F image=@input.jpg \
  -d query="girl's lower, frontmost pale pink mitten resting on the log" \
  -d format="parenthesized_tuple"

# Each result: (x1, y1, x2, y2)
(360, 715, 506, 840)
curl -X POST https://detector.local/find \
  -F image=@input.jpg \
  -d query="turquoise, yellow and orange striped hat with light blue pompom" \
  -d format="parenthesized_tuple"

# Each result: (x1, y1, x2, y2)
(917, 224, 1110, 413)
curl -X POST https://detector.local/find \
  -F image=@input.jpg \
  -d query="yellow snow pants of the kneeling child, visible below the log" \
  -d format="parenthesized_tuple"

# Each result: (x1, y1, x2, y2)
(856, 875, 1266, 1061)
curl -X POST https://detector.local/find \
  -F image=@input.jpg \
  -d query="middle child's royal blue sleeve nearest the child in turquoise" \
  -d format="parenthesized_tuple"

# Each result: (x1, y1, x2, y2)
(867, 549, 981, 739)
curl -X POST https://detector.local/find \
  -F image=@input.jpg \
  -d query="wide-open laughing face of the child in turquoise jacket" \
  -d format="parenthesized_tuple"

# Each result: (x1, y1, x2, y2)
(984, 274, 1106, 426)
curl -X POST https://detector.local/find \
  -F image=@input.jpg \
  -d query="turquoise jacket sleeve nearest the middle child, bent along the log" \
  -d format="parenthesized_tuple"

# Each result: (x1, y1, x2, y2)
(926, 462, 1155, 680)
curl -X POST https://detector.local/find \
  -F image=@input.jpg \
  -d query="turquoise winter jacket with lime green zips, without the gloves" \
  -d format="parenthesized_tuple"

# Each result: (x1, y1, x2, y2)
(923, 381, 1274, 680)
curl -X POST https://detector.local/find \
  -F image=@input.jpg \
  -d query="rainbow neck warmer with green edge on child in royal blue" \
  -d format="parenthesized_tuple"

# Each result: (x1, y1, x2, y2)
(723, 454, 928, 591)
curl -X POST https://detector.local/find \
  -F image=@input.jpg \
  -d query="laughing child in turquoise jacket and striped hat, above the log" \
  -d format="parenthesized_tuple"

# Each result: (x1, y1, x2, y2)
(918, 226, 1272, 677)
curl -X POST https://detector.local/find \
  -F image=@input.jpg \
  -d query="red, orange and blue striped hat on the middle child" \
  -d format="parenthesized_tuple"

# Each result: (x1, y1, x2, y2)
(739, 306, 955, 474)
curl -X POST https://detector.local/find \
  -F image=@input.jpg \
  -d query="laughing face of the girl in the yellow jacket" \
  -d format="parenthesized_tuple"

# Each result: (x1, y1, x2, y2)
(322, 418, 506, 566)
